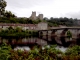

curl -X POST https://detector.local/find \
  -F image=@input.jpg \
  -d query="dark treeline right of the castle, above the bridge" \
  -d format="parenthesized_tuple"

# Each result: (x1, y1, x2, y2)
(44, 17, 79, 26)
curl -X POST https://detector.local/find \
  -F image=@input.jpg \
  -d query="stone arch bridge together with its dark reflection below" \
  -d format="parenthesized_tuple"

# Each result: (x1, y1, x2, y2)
(38, 27, 80, 46)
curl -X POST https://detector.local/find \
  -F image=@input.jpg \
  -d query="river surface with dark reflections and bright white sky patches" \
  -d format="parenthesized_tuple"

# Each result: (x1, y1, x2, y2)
(0, 35, 78, 51)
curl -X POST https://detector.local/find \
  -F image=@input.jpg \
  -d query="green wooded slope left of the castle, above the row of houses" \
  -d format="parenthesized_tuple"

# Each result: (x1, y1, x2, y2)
(0, 17, 41, 24)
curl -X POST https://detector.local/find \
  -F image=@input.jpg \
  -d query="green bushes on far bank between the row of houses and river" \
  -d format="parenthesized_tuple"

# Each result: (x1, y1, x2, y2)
(0, 27, 38, 37)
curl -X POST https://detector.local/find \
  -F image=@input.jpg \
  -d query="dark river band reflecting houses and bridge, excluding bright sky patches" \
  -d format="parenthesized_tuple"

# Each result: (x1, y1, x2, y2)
(0, 36, 77, 46)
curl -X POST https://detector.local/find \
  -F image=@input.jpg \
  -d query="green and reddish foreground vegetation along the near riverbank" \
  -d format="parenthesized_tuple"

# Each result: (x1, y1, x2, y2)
(0, 43, 80, 60)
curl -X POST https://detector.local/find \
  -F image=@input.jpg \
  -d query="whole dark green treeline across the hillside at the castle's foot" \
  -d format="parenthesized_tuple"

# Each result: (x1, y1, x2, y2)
(0, 17, 79, 27)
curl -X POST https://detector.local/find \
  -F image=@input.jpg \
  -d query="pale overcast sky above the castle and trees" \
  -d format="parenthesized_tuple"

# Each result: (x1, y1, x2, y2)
(5, 0, 80, 19)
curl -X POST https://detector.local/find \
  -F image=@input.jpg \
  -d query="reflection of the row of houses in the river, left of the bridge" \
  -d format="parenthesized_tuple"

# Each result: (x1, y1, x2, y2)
(0, 37, 47, 46)
